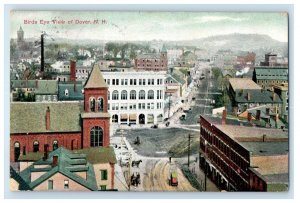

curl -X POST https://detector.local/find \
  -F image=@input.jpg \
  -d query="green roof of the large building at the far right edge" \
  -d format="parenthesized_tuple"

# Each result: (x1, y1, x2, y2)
(253, 67, 288, 81)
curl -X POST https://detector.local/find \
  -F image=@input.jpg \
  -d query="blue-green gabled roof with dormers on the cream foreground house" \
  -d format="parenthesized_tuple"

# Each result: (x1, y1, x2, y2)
(20, 147, 98, 191)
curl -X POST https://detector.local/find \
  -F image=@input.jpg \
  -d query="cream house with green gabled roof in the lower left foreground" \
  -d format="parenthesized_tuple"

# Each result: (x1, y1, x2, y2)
(11, 146, 116, 191)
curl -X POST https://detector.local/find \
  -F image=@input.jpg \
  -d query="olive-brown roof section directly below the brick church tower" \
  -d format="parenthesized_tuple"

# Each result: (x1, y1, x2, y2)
(74, 147, 117, 164)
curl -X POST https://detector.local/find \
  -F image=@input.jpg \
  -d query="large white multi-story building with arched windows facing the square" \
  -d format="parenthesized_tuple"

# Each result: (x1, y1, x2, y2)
(102, 71, 166, 124)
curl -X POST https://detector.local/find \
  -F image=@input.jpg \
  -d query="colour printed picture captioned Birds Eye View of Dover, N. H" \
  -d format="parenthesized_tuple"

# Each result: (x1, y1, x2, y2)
(10, 10, 289, 192)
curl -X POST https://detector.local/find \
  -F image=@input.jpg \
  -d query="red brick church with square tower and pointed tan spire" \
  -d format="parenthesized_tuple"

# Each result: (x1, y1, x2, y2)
(10, 65, 110, 162)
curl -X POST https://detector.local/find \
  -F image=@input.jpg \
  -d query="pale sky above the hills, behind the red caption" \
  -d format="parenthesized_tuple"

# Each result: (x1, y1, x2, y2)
(10, 11, 288, 42)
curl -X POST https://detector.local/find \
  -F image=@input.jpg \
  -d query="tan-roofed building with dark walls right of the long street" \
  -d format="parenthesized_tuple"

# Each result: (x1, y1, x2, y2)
(228, 78, 282, 114)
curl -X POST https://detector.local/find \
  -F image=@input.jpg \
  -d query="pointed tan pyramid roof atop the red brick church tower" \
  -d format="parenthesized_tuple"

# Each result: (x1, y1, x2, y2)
(84, 64, 108, 88)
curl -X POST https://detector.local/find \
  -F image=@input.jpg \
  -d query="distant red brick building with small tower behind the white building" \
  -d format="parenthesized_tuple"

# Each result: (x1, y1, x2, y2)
(135, 48, 168, 71)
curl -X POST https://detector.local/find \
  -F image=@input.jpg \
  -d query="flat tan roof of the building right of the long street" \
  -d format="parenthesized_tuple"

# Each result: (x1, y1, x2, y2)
(229, 78, 261, 91)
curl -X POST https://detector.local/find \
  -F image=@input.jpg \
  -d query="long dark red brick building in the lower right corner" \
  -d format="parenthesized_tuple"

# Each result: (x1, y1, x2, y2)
(199, 110, 289, 191)
